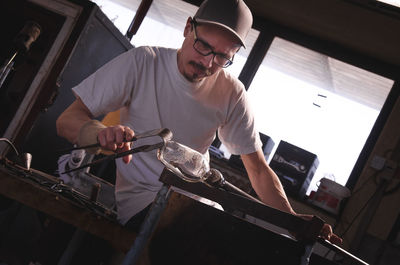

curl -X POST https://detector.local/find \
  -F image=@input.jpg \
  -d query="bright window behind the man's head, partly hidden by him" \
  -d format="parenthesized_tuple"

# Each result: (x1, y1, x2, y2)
(92, 0, 259, 76)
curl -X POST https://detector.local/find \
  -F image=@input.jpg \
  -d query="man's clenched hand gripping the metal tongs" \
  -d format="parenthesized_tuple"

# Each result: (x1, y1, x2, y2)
(97, 125, 135, 164)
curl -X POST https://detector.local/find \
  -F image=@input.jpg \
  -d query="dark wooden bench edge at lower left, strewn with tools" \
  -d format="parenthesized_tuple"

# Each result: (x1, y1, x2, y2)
(0, 160, 136, 252)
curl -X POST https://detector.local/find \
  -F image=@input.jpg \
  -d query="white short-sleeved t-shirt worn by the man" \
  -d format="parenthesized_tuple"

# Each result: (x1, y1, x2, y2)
(73, 47, 261, 224)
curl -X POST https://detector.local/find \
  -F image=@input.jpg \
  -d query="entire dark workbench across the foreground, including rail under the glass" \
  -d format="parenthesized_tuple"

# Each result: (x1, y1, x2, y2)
(0, 156, 368, 265)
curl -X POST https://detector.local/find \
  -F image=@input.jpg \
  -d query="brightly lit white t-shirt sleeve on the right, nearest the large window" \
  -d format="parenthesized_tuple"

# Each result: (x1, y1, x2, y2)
(218, 86, 262, 155)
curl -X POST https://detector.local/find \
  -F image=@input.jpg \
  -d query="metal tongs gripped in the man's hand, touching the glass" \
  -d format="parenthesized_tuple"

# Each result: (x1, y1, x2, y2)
(61, 128, 172, 174)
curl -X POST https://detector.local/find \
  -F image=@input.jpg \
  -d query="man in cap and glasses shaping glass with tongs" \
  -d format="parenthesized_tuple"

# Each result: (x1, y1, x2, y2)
(57, 0, 340, 242)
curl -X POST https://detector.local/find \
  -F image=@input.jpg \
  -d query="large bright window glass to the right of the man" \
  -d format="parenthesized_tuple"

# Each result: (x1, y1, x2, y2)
(248, 37, 394, 193)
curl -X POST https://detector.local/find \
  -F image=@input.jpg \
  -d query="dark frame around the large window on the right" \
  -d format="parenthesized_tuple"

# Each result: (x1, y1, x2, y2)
(239, 17, 400, 190)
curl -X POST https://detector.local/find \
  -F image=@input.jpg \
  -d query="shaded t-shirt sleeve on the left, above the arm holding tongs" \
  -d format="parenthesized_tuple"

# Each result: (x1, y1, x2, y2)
(72, 49, 138, 117)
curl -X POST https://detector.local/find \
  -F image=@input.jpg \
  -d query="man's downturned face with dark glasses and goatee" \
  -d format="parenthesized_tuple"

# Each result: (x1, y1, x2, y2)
(178, 18, 240, 82)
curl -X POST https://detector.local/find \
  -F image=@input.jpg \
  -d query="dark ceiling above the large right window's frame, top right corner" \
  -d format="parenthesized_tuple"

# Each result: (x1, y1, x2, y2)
(242, 0, 400, 66)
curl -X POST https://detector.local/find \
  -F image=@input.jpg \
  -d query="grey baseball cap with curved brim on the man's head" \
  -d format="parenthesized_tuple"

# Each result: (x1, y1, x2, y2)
(194, 0, 253, 47)
